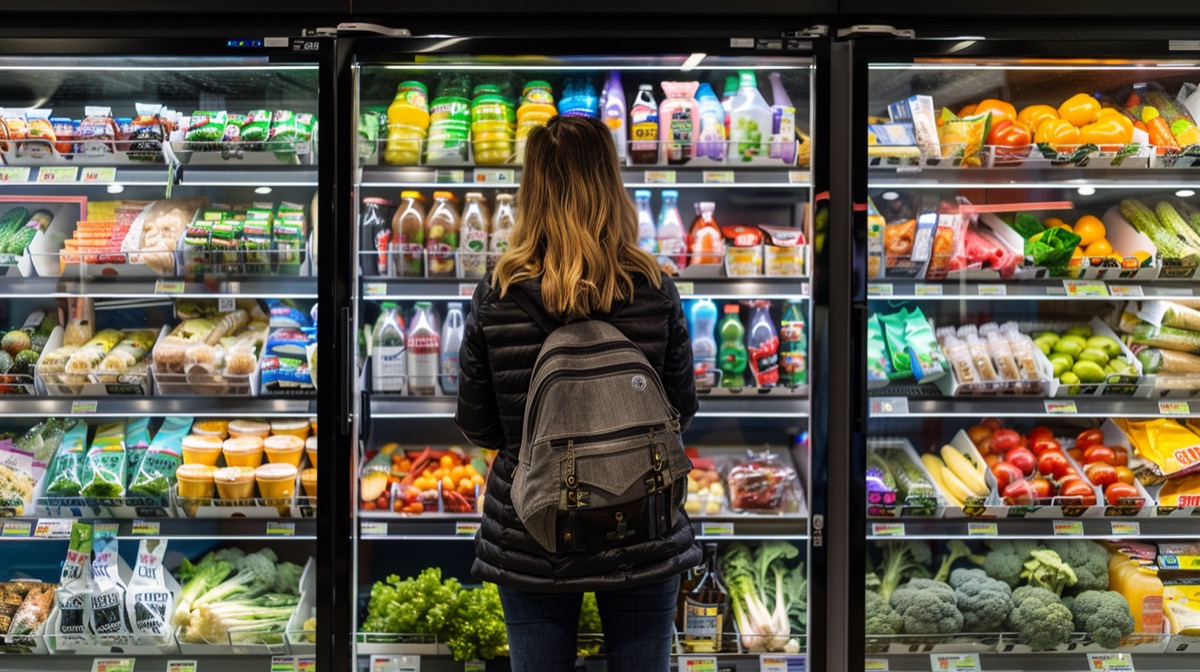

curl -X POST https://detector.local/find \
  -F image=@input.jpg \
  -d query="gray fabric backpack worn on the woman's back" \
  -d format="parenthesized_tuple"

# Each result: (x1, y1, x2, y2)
(510, 287, 691, 553)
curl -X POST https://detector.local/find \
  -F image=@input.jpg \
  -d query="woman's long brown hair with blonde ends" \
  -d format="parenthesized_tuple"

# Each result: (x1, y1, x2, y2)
(492, 116, 661, 317)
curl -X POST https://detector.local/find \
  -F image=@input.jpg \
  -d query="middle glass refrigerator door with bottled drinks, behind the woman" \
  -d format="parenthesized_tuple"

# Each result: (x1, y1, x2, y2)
(354, 41, 814, 670)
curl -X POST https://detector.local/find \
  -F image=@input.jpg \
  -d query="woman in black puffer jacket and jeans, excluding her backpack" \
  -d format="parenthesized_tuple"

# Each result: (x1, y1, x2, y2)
(456, 116, 701, 672)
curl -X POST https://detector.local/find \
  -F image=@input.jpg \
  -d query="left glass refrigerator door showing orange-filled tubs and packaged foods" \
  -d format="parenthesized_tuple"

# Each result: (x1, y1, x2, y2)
(0, 40, 332, 671)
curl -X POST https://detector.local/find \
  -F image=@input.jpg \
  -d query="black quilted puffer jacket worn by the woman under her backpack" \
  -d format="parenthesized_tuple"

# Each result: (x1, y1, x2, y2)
(456, 270, 701, 592)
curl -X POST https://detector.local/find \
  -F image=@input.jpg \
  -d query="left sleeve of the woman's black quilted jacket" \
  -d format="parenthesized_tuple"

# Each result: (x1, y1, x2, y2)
(455, 282, 504, 450)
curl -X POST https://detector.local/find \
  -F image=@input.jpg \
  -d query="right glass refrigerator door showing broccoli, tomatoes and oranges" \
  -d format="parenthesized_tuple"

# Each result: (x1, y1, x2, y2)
(854, 42, 1200, 670)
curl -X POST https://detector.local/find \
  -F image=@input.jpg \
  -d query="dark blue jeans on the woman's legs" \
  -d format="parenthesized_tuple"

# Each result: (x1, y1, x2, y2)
(500, 576, 679, 672)
